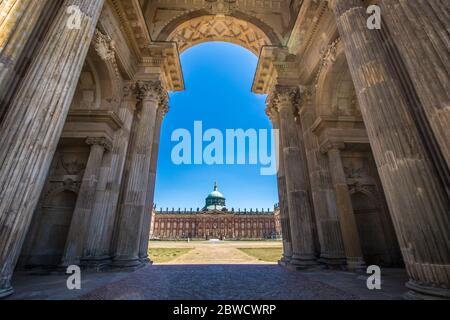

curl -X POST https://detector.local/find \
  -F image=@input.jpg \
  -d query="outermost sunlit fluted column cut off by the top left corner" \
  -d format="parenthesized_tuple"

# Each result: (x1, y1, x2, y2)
(0, 0, 48, 119)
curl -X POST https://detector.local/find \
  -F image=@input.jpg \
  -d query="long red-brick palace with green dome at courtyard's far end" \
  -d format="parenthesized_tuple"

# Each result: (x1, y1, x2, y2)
(150, 184, 281, 240)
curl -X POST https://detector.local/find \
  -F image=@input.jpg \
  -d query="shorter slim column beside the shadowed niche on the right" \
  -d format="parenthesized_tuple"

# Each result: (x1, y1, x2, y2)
(321, 142, 365, 271)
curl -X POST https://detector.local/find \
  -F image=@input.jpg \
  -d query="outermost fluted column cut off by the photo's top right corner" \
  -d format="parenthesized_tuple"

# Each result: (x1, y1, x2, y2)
(380, 0, 450, 172)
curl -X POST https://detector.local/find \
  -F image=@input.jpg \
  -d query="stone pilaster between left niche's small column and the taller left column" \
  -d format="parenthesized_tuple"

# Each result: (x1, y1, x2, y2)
(81, 82, 137, 269)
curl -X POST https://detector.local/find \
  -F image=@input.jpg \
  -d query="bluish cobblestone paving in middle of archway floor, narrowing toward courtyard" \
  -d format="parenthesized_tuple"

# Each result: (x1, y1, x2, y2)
(81, 265, 358, 300)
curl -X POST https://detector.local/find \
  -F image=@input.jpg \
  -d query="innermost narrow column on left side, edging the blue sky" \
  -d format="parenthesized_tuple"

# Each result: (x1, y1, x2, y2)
(139, 96, 169, 262)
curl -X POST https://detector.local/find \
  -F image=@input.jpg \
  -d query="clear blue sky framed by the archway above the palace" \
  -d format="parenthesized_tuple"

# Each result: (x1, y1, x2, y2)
(155, 42, 278, 209)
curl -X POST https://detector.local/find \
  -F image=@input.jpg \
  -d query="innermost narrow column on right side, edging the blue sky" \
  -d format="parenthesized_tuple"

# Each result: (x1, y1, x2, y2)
(267, 108, 292, 265)
